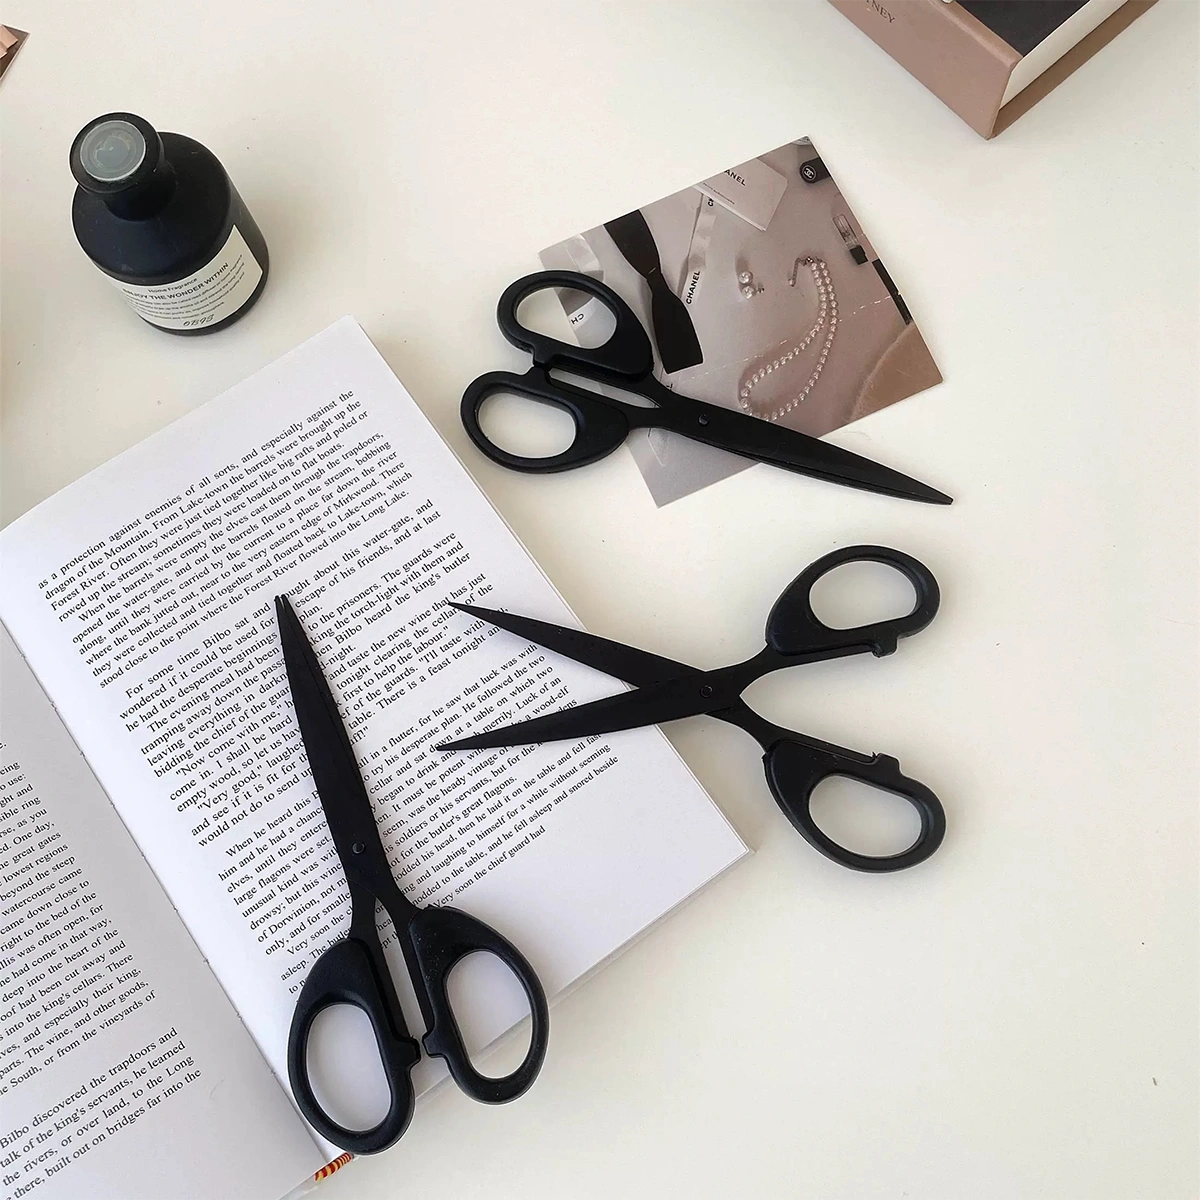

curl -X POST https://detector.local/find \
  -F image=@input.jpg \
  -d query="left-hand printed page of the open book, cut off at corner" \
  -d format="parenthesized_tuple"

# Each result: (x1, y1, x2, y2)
(0, 626, 323, 1200)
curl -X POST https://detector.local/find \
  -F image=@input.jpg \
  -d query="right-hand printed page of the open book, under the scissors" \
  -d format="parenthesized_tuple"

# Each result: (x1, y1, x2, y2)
(0, 319, 745, 1123)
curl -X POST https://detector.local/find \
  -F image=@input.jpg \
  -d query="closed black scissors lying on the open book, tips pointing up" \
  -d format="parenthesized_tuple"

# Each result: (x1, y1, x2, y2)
(275, 596, 550, 1154)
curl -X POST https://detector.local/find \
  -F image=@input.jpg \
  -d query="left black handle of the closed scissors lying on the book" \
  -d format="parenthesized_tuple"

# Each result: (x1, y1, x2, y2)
(288, 937, 421, 1154)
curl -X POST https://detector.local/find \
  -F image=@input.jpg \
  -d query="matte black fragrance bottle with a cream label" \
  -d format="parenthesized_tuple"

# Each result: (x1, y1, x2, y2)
(71, 113, 268, 336)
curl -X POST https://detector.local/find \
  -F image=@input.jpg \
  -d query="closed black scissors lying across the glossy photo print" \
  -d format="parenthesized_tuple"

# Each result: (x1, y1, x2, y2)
(462, 271, 950, 504)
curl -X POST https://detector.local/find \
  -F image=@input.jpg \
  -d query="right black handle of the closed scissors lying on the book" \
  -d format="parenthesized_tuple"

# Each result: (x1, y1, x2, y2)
(407, 908, 550, 1104)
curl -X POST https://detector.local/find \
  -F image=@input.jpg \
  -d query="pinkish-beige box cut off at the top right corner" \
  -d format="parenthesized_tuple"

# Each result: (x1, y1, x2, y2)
(829, 0, 1154, 138)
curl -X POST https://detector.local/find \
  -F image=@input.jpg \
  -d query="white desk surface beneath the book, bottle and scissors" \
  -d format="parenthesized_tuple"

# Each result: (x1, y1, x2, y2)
(0, 0, 1200, 1200)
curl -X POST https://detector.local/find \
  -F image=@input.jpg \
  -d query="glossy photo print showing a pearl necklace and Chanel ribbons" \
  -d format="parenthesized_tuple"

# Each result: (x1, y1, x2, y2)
(541, 138, 942, 505)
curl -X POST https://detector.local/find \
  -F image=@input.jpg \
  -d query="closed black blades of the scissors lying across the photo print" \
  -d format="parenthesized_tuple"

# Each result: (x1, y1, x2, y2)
(661, 401, 953, 504)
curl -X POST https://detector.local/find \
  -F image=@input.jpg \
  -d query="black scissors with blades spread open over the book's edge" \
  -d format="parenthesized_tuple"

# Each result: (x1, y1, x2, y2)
(438, 546, 946, 871)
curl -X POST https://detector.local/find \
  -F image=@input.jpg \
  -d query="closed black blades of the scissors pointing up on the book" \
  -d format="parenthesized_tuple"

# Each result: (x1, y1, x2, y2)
(275, 596, 389, 881)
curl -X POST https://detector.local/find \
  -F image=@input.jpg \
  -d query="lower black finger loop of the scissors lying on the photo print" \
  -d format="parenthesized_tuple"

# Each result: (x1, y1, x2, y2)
(460, 367, 636, 475)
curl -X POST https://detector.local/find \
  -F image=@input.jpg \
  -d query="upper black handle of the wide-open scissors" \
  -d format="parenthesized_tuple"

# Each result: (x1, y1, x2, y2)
(767, 546, 941, 661)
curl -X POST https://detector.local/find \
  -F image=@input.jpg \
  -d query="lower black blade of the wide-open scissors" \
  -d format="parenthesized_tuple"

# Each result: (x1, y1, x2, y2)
(437, 668, 724, 750)
